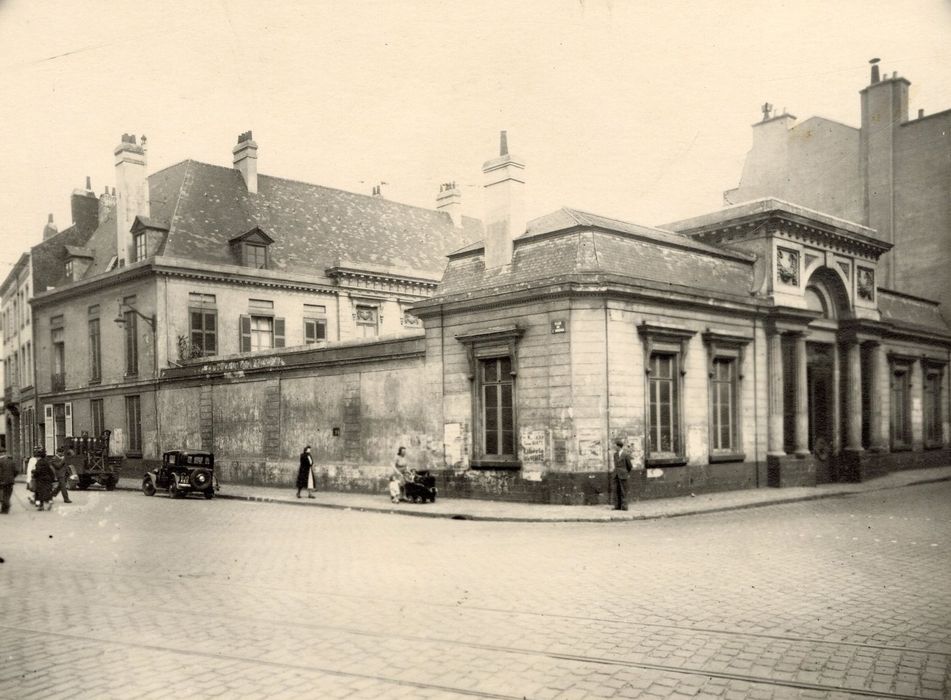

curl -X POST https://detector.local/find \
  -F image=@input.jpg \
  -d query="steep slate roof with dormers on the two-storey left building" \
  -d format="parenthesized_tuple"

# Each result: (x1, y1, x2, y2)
(37, 160, 482, 291)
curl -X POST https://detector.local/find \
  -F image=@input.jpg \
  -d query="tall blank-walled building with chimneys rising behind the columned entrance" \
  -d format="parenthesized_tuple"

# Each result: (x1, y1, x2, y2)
(724, 59, 951, 318)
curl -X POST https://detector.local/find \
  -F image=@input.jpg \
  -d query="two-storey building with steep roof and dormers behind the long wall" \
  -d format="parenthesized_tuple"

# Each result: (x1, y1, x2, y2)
(33, 132, 481, 458)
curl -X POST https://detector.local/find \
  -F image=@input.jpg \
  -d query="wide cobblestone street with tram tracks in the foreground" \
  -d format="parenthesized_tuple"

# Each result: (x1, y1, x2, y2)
(0, 482, 951, 700)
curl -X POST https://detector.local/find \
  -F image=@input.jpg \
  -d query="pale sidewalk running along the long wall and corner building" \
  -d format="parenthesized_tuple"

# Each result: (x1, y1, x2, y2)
(108, 466, 951, 522)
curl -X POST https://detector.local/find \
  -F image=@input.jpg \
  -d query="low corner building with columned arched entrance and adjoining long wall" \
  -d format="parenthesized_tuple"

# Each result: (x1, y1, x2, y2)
(151, 133, 951, 504)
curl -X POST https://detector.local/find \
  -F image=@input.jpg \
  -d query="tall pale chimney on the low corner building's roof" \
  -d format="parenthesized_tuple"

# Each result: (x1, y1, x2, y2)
(482, 131, 526, 269)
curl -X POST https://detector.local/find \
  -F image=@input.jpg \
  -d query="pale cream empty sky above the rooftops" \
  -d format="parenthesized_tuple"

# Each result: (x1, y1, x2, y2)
(0, 0, 951, 278)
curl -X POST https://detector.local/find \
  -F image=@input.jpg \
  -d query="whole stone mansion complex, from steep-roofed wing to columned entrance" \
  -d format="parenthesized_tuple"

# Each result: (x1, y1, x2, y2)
(18, 130, 951, 504)
